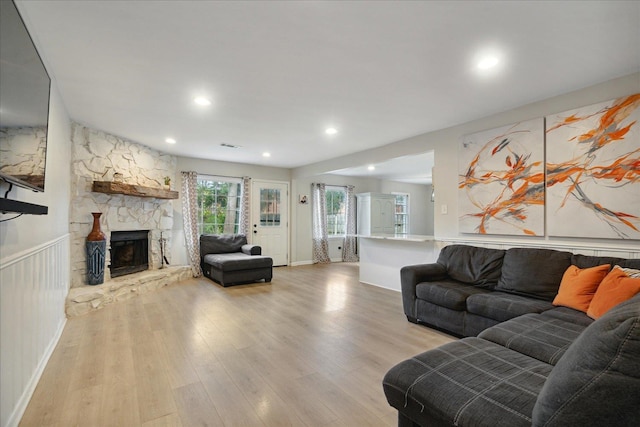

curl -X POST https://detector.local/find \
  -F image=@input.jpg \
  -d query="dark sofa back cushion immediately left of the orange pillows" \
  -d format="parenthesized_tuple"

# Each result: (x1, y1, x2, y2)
(495, 248, 572, 301)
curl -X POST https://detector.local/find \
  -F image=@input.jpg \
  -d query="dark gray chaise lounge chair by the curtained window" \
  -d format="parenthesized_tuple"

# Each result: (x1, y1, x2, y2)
(200, 234, 273, 287)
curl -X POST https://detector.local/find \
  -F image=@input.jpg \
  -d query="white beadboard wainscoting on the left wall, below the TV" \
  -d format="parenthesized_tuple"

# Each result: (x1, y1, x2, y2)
(0, 234, 70, 427)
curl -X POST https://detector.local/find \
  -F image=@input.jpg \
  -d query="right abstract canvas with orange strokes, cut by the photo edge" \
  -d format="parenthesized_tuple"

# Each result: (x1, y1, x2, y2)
(546, 93, 640, 239)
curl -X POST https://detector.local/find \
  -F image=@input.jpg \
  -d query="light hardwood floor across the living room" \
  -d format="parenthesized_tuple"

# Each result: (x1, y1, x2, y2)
(20, 263, 452, 427)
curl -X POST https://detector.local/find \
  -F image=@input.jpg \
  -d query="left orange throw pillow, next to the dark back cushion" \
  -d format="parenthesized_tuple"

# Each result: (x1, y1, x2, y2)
(553, 264, 611, 313)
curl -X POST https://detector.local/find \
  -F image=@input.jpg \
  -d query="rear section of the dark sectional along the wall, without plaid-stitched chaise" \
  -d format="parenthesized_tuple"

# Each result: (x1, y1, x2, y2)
(400, 245, 640, 336)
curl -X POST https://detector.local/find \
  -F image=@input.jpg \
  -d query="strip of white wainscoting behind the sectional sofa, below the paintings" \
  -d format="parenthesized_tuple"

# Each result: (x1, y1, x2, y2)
(438, 237, 640, 259)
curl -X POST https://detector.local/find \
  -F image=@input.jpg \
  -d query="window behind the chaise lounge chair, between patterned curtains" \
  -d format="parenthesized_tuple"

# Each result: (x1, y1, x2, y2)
(198, 176, 242, 234)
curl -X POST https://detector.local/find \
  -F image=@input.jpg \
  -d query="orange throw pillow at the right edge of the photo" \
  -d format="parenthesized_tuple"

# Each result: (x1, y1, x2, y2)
(587, 265, 640, 319)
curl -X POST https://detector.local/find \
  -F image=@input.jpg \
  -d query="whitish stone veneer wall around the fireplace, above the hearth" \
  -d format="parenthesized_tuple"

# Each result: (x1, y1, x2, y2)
(69, 123, 177, 288)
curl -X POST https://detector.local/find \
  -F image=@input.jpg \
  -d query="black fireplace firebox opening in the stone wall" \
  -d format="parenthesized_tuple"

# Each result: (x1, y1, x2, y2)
(109, 230, 149, 277)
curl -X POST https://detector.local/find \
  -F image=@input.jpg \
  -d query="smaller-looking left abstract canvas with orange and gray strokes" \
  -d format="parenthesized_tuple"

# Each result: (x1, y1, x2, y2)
(458, 118, 544, 236)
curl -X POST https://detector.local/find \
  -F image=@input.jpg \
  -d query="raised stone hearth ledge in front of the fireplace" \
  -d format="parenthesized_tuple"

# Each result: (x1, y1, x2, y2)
(65, 266, 193, 317)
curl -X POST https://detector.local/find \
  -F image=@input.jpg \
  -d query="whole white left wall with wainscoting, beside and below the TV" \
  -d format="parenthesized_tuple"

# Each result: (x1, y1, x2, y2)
(0, 81, 71, 426)
